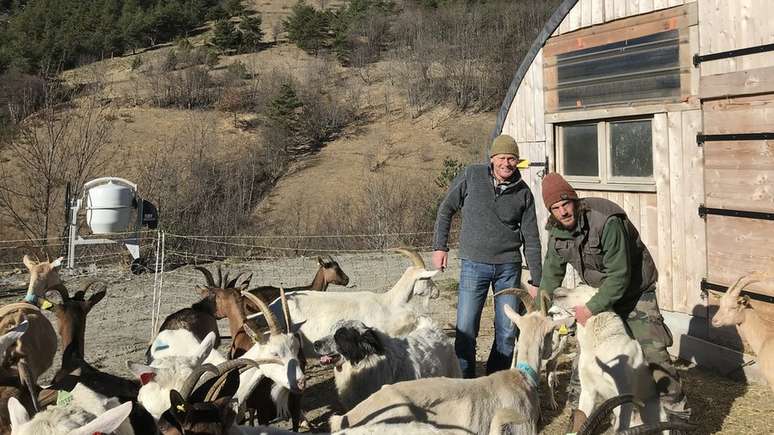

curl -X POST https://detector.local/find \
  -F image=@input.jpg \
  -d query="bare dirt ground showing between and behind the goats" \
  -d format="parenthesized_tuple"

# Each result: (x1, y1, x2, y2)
(0, 253, 774, 434)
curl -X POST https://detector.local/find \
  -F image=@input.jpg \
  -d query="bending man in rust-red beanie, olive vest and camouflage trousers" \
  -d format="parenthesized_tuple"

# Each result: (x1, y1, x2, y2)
(538, 173, 690, 432)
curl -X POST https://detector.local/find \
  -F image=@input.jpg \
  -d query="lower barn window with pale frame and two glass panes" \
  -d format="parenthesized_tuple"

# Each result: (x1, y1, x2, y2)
(557, 118, 655, 191)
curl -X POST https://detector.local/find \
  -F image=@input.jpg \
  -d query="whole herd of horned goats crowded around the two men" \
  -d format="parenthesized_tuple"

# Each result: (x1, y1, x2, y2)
(0, 249, 774, 435)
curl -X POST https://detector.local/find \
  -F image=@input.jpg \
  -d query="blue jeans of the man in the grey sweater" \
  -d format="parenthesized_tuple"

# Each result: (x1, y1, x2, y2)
(454, 259, 521, 378)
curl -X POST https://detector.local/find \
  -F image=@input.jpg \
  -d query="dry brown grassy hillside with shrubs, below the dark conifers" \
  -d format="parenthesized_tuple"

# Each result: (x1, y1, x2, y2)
(0, 0, 551, 258)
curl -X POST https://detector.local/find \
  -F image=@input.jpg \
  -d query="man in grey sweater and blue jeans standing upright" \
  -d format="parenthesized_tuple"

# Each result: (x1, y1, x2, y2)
(433, 135, 541, 378)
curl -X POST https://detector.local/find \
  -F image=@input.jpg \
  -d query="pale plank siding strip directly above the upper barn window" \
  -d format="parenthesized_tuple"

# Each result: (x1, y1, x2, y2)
(554, 0, 697, 36)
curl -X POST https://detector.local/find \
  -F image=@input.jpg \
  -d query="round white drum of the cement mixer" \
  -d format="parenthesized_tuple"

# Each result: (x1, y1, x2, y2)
(86, 181, 134, 234)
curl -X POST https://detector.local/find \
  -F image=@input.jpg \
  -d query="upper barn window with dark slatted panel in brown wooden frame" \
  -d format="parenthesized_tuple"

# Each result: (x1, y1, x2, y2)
(543, 4, 698, 113)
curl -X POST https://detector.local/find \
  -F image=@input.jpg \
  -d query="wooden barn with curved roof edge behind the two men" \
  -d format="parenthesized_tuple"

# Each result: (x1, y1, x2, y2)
(493, 0, 774, 377)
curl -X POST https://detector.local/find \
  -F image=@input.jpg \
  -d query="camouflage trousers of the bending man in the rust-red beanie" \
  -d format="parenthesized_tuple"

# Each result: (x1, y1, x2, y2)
(567, 285, 691, 419)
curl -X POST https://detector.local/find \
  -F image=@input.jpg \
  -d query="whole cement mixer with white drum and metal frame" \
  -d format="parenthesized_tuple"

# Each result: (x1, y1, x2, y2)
(67, 177, 158, 274)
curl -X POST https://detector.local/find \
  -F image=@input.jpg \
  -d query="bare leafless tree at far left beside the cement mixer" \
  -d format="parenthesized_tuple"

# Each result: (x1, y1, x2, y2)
(0, 86, 112, 247)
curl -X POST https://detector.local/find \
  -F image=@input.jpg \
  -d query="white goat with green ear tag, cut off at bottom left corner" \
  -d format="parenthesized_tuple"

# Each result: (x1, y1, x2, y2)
(8, 384, 134, 435)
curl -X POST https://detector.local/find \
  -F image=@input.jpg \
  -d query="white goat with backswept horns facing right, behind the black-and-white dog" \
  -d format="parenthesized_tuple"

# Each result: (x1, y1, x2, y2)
(260, 249, 438, 356)
